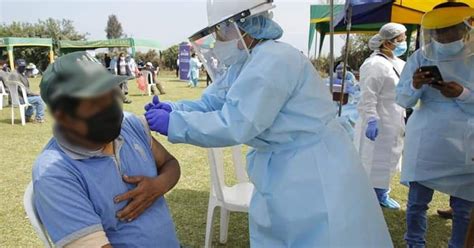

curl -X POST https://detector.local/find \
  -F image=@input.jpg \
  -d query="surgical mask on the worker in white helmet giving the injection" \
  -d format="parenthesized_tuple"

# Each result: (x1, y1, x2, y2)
(214, 39, 248, 66)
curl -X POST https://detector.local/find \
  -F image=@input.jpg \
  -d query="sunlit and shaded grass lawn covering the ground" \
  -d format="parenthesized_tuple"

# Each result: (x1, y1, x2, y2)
(0, 72, 451, 247)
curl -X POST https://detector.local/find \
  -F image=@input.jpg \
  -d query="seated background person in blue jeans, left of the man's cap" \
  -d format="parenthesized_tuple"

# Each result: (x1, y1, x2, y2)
(8, 59, 45, 123)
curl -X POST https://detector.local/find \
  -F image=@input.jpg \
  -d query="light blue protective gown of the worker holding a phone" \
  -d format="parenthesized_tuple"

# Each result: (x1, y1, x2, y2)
(397, 51, 474, 201)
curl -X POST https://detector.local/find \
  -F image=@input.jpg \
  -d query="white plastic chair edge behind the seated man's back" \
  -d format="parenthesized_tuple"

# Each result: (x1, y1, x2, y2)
(23, 182, 53, 248)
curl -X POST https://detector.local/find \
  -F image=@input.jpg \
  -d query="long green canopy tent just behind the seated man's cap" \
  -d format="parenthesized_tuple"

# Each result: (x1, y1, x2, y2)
(58, 38, 161, 56)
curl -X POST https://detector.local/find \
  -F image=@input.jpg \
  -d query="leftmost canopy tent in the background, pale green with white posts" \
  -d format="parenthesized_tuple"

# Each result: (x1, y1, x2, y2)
(0, 37, 54, 69)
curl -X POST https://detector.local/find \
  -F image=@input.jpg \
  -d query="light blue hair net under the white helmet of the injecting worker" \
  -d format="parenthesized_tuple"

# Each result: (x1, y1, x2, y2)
(238, 15, 283, 40)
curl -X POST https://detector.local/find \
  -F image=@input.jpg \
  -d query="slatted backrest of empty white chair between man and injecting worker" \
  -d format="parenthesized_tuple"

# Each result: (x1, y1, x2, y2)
(208, 146, 248, 201)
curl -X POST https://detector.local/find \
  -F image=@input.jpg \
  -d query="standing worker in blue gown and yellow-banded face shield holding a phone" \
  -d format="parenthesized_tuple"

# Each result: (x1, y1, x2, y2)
(397, 3, 474, 247)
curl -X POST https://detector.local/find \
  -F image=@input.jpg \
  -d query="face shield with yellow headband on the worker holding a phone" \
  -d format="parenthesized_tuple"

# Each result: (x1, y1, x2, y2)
(421, 8, 474, 61)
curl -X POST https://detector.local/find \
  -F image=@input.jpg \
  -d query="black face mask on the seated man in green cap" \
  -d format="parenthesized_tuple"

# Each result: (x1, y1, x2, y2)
(77, 100, 123, 144)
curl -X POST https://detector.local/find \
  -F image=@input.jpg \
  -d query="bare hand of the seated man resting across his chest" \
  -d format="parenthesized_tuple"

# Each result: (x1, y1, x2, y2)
(114, 176, 168, 222)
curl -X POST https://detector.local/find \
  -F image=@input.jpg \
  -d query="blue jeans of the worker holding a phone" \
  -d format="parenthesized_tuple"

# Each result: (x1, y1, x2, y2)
(405, 182, 474, 248)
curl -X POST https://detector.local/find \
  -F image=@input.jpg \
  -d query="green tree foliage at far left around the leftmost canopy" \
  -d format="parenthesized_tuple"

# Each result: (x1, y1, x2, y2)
(0, 18, 88, 70)
